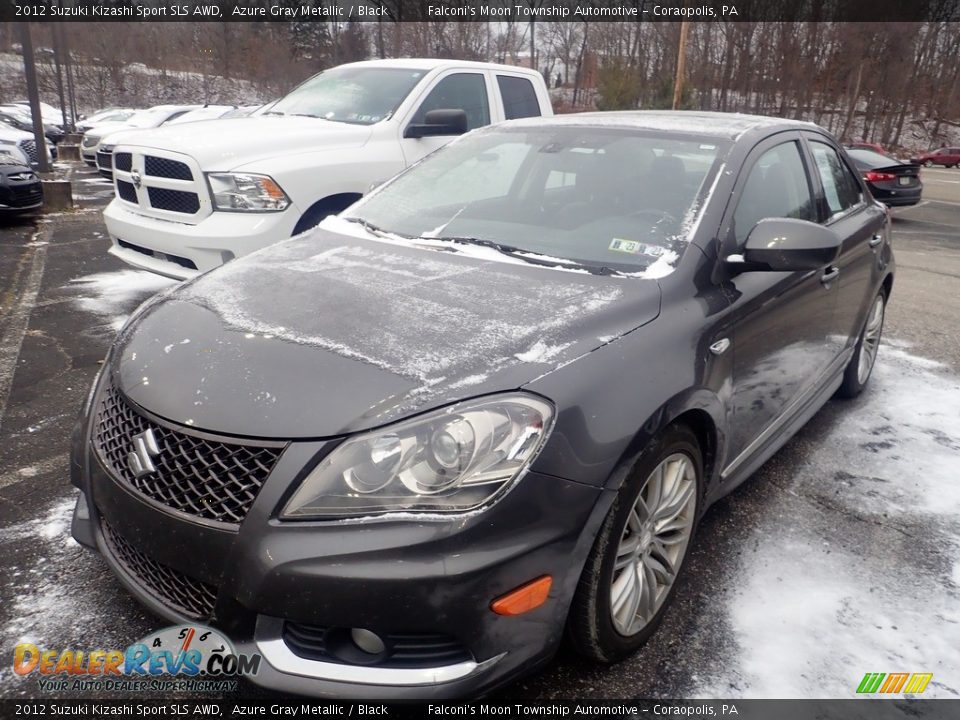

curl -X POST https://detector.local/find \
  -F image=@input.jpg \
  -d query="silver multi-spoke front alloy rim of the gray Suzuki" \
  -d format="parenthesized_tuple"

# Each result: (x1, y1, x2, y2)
(610, 453, 697, 636)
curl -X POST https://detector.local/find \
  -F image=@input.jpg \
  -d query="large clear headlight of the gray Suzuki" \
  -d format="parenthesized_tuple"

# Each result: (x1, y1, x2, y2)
(283, 393, 553, 519)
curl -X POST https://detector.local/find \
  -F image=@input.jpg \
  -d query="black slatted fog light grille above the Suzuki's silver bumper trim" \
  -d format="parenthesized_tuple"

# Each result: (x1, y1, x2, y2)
(283, 622, 473, 668)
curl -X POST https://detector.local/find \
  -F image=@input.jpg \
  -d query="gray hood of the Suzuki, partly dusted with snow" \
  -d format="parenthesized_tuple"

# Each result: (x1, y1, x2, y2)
(112, 229, 660, 439)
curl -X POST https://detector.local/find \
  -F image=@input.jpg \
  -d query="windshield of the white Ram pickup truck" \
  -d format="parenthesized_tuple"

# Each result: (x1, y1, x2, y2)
(264, 67, 426, 125)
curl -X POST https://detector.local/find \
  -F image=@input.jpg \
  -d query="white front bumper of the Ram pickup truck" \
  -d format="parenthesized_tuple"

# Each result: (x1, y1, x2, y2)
(103, 198, 300, 280)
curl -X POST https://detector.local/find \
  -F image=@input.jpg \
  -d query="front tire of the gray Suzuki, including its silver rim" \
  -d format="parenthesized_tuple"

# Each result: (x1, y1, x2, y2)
(567, 425, 703, 663)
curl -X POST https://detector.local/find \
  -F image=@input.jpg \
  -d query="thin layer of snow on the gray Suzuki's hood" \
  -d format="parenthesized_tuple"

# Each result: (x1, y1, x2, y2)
(179, 237, 622, 388)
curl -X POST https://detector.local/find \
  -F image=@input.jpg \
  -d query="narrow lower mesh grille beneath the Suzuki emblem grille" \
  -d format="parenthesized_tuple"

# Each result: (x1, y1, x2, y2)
(100, 519, 217, 620)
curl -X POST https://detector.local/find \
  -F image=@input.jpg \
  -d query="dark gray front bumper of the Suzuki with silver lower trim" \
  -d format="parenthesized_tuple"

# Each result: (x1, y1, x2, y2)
(72, 390, 612, 700)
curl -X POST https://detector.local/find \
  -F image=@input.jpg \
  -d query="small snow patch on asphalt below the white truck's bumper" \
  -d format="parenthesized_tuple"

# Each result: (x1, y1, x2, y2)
(63, 270, 176, 332)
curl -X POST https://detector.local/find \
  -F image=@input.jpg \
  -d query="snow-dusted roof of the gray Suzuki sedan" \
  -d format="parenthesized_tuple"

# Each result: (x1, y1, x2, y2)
(508, 110, 821, 140)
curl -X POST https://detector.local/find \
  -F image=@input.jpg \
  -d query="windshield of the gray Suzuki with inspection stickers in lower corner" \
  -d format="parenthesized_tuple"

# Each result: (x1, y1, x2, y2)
(344, 126, 728, 277)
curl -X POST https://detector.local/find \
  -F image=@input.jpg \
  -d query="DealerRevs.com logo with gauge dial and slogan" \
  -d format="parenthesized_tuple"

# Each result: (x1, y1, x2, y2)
(13, 625, 261, 692)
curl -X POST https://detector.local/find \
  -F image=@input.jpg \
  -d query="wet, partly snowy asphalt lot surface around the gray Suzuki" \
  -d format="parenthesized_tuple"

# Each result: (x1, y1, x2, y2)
(0, 163, 960, 700)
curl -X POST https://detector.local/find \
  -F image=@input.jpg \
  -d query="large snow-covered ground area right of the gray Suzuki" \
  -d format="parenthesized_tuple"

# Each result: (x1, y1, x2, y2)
(695, 343, 960, 698)
